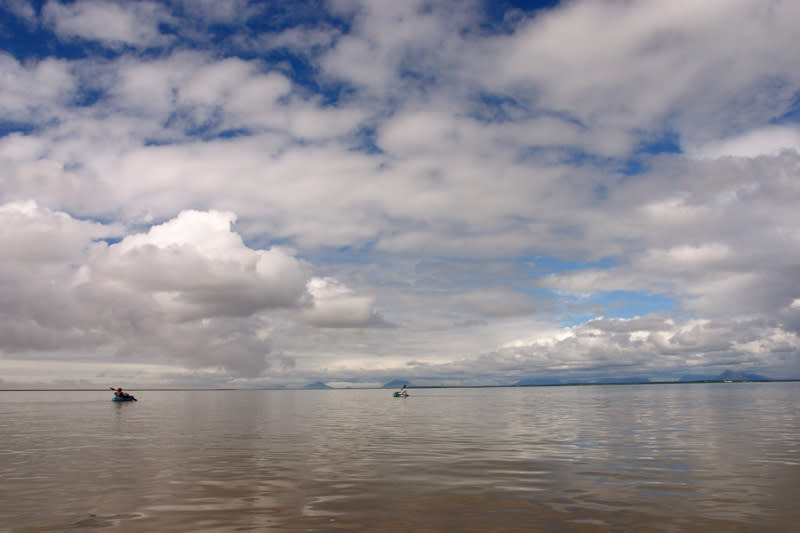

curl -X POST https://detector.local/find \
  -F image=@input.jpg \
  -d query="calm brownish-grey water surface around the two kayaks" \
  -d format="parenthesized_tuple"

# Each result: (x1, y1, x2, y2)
(0, 383, 800, 532)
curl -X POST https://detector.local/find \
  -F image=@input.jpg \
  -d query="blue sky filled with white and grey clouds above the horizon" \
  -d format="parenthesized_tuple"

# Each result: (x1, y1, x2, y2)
(0, 0, 800, 388)
